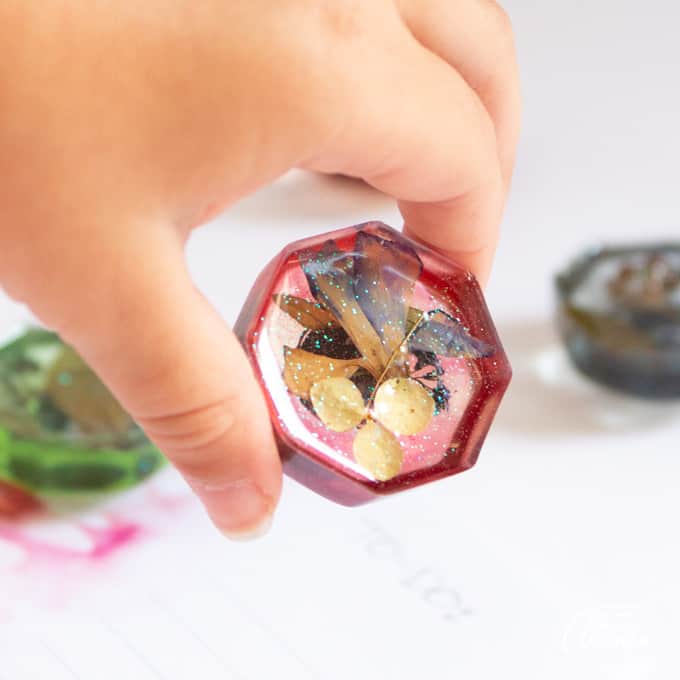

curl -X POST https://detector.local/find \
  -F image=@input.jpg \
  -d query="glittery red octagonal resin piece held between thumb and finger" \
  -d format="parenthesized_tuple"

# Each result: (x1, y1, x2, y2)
(236, 222, 511, 505)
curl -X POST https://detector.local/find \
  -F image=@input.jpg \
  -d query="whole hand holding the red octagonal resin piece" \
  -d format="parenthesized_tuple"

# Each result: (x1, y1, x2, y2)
(0, 0, 519, 535)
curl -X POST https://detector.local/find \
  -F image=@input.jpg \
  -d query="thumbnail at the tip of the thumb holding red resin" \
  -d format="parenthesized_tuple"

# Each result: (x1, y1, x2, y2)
(217, 479, 274, 541)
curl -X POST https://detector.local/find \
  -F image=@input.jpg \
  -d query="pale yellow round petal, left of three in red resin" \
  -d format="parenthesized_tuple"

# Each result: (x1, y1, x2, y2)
(309, 378, 366, 432)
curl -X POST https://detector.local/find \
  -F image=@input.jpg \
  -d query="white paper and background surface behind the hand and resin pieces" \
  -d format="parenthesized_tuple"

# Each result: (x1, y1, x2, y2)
(0, 0, 680, 680)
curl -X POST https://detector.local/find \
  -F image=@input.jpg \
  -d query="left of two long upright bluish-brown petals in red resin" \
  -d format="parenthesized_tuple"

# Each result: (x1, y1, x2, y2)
(299, 241, 390, 375)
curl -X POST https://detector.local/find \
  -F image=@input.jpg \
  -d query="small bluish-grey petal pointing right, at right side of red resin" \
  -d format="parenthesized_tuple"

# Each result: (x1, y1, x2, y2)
(408, 310, 494, 359)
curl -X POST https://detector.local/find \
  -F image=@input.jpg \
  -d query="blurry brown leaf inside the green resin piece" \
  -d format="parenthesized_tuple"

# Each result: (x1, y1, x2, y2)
(46, 347, 133, 435)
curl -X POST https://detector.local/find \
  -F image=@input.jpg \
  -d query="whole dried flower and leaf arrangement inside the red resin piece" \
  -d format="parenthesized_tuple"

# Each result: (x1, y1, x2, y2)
(274, 231, 493, 481)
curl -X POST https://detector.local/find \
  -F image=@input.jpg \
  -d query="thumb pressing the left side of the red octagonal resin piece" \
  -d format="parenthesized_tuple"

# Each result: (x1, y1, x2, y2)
(49, 228, 281, 538)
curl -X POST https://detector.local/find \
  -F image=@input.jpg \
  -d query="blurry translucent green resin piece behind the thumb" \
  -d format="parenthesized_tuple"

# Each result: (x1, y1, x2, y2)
(0, 329, 164, 514)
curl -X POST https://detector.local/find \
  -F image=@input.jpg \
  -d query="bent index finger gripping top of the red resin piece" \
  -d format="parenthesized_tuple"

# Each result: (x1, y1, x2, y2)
(307, 10, 505, 282)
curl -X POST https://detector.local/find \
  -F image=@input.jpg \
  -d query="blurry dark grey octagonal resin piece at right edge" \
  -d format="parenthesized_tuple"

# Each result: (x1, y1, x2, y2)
(556, 243, 680, 399)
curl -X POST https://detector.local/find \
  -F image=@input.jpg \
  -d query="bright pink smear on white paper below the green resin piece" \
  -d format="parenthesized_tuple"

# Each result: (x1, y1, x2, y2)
(0, 470, 196, 625)
